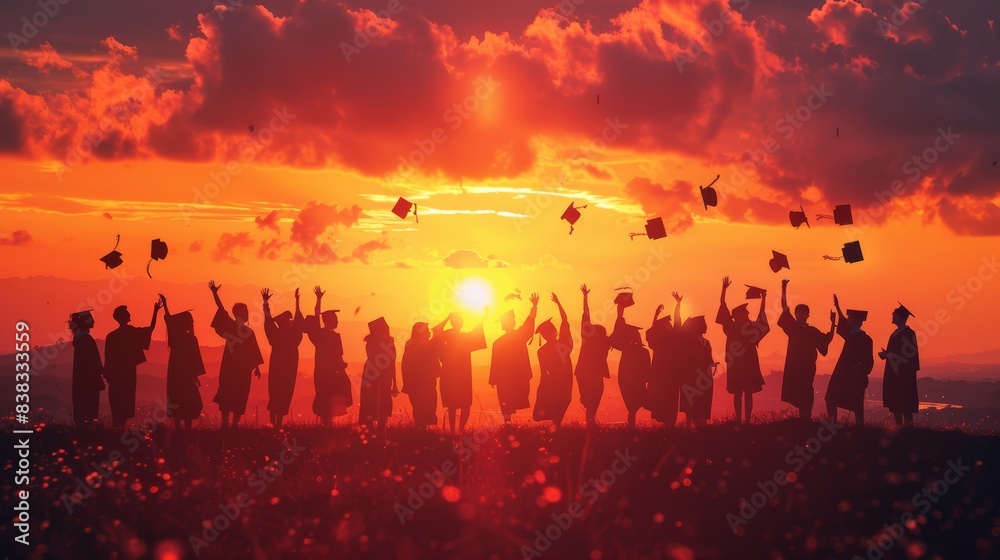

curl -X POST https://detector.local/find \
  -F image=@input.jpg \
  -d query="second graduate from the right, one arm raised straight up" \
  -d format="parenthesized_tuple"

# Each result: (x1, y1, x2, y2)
(826, 295, 875, 426)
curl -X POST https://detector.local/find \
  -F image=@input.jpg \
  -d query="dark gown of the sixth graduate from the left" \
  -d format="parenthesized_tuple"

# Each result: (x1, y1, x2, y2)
(306, 324, 354, 418)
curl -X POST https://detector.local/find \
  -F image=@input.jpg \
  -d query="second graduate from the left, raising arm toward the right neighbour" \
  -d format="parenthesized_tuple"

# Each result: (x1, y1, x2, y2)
(104, 299, 163, 427)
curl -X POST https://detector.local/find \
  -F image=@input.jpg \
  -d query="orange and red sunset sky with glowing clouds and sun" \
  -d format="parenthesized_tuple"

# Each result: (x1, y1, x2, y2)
(0, 0, 1000, 364)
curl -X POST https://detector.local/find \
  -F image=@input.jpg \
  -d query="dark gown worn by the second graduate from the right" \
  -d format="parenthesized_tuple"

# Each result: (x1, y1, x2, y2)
(826, 324, 875, 412)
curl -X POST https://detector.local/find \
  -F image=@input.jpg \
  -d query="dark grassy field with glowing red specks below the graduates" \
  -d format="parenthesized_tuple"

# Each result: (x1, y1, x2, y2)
(0, 420, 1000, 560)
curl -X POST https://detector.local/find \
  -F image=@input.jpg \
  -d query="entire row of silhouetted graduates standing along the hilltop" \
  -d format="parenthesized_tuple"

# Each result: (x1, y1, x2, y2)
(69, 277, 920, 428)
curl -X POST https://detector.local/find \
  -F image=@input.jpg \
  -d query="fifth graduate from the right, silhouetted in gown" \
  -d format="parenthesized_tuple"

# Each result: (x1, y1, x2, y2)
(679, 315, 719, 424)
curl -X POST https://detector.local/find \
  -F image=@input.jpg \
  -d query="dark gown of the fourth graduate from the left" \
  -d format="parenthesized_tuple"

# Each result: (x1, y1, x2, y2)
(212, 309, 264, 415)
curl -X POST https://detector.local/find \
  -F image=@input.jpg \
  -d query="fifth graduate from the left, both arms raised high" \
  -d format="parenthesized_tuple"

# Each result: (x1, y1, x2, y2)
(260, 288, 305, 428)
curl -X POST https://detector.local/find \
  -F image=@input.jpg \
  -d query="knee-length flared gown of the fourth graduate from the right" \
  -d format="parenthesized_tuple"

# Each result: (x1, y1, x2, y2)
(715, 303, 771, 395)
